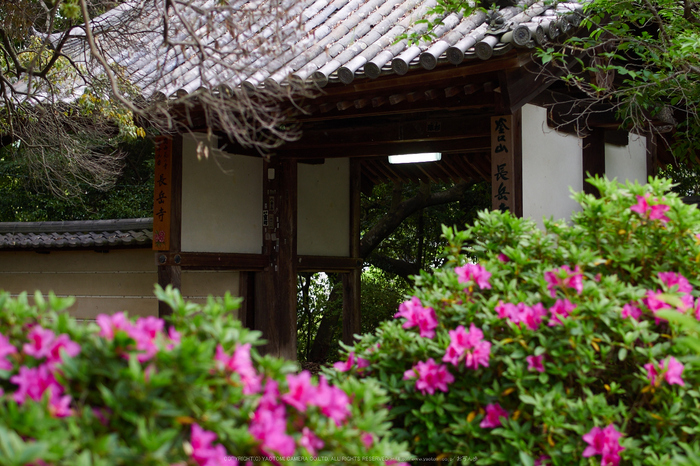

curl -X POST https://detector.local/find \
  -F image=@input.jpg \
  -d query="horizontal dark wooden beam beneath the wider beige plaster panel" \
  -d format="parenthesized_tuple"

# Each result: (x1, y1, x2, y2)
(156, 251, 270, 271)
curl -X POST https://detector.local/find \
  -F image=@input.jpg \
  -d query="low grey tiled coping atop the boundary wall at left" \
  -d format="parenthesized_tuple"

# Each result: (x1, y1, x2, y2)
(0, 218, 153, 250)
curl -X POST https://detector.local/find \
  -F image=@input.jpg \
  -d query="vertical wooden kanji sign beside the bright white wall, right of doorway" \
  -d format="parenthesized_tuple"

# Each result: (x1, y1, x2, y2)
(491, 115, 517, 212)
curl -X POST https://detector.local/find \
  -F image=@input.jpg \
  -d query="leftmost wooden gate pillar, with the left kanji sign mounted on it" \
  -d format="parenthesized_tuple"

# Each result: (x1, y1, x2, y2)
(153, 134, 182, 317)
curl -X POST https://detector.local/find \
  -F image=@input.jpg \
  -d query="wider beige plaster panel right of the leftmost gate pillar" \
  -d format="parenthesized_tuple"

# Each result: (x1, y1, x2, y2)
(182, 135, 263, 254)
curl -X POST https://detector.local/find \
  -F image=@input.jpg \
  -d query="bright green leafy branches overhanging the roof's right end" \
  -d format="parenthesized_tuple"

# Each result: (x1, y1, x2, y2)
(409, 0, 700, 163)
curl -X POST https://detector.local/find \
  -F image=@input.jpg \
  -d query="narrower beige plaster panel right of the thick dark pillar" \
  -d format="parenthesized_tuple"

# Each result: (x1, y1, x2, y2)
(297, 158, 350, 257)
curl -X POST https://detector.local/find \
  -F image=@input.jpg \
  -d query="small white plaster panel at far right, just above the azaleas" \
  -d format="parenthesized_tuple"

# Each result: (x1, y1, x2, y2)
(605, 133, 647, 184)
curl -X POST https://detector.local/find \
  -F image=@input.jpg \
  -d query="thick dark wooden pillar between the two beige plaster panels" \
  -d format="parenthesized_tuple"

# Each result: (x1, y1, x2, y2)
(254, 157, 297, 360)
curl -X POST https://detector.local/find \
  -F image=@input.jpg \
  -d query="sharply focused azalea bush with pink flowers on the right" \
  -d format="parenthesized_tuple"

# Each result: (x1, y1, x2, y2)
(327, 178, 700, 466)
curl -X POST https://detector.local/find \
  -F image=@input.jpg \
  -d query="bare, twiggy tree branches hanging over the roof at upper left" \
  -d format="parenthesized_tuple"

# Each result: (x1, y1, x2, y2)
(0, 0, 300, 196)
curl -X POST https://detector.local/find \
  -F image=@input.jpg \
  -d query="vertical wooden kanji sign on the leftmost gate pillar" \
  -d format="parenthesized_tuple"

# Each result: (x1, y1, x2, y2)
(153, 136, 173, 251)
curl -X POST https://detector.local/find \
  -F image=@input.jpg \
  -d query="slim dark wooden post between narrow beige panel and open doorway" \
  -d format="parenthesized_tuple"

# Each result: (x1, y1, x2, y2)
(342, 159, 362, 345)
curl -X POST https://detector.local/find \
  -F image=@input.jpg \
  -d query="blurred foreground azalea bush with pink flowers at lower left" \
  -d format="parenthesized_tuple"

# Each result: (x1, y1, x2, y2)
(0, 289, 409, 466)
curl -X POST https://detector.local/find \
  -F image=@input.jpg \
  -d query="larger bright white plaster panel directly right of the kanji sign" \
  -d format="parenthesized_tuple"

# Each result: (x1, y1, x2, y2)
(522, 104, 583, 227)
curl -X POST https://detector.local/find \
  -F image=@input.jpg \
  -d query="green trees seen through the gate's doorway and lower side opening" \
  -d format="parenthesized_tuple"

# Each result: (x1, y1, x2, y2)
(297, 178, 490, 363)
